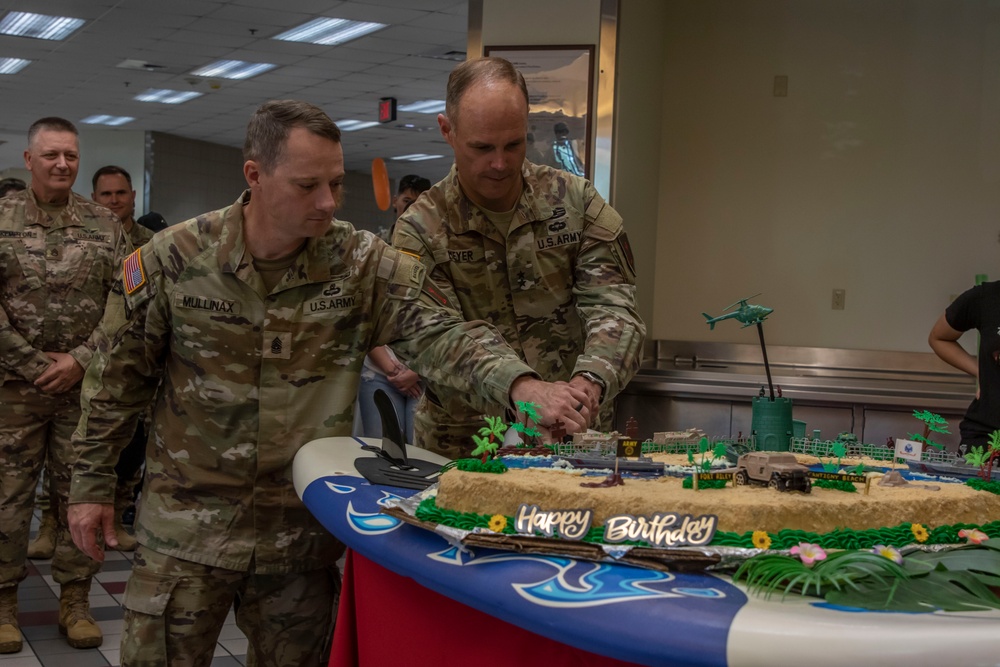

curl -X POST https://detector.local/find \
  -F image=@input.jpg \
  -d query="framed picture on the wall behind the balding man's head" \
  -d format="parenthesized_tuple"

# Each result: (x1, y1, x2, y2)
(483, 45, 594, 179)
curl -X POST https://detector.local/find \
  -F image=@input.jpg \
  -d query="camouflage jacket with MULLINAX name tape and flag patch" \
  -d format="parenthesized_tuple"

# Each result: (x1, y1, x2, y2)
(70, 193, 531, 573)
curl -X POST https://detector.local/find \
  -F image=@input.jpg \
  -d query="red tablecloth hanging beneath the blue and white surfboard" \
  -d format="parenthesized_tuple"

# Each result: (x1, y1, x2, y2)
(330, 550, 634, 667)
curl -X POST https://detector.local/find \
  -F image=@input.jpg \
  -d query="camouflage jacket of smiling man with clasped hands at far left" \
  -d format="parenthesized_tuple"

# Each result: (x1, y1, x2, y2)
(0, 188, 122, 384)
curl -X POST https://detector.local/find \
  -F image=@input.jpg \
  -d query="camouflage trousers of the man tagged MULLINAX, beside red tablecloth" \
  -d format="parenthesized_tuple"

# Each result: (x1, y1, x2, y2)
(121, 545, 340, 667)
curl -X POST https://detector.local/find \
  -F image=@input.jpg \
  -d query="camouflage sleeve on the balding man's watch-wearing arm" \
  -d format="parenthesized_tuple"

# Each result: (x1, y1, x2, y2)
(573, 183, 646, 397)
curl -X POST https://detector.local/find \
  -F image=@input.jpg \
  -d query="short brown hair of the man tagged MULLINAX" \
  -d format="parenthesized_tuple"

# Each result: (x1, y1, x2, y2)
(243, 100, 340, 174)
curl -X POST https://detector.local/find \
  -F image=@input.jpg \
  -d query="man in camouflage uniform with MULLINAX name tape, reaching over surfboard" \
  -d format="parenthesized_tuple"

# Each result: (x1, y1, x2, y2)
(70, 101, 584, 667)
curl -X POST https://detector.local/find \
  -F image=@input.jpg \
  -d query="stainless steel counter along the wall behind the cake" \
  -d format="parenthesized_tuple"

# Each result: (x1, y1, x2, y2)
(617, 341, 975, 447)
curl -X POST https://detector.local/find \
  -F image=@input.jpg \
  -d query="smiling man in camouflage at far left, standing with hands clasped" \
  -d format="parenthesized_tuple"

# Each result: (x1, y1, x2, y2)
(0, 118, 121, 653)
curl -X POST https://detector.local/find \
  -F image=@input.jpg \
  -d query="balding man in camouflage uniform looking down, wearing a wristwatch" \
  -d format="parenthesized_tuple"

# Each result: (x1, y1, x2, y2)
(393, 58, 646, 458)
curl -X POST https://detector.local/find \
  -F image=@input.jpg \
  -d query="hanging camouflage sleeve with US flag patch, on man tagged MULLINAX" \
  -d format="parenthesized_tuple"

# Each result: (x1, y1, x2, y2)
(69, 246, 169, 504)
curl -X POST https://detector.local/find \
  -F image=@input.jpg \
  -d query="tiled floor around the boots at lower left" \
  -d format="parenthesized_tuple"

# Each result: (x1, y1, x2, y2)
(0, 516, 247, 667)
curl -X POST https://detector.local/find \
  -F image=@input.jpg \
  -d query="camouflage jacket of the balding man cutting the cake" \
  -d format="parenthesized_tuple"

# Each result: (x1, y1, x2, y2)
(393, 161, 646, 422)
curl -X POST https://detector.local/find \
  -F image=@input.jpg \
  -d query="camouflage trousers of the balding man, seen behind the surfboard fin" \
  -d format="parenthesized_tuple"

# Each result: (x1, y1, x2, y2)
(413, 392, 614, 459)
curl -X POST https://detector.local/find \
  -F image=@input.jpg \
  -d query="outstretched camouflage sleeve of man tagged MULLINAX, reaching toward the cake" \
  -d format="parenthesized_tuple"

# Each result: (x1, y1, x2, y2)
(375, 248, 538, 408)
